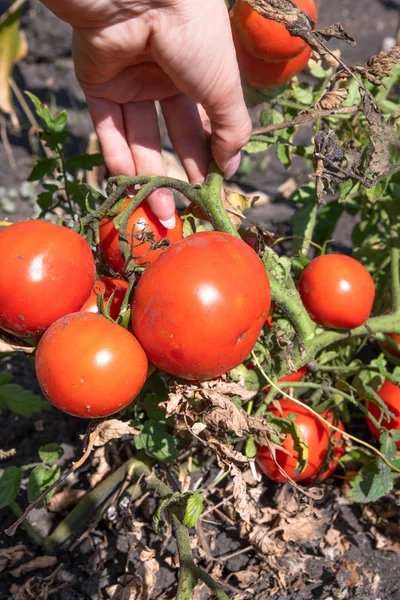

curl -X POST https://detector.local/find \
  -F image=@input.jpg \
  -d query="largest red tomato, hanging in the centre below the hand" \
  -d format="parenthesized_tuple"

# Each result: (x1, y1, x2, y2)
(132, 231, 271, 380)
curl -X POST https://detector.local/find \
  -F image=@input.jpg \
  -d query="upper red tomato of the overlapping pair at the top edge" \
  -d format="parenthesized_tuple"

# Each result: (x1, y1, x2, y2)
(232, 0, 317, 62)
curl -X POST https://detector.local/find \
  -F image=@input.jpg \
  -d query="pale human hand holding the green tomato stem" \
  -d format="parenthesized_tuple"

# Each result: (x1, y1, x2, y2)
(42, 0, 251, 228)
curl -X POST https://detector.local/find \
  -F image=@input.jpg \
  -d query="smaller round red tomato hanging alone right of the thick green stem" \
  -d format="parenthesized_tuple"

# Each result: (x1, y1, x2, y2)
(298, 254, 375, 329)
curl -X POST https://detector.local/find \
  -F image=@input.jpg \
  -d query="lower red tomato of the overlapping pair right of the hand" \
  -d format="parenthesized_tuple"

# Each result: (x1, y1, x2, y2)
(231, 12, 311, 89)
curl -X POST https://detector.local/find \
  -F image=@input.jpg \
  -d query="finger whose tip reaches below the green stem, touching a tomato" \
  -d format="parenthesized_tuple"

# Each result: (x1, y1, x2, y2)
(122, 101, 175, 229)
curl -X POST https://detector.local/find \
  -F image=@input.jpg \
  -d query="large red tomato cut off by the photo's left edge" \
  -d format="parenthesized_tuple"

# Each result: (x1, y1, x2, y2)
(0, 220, 95, 337)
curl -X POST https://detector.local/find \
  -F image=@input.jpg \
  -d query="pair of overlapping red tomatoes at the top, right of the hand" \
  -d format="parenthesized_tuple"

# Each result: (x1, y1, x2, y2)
(230, 0, 317, 89)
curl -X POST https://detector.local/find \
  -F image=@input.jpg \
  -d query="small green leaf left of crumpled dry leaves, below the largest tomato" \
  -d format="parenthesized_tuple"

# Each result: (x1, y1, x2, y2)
(134, 419, 178, 462)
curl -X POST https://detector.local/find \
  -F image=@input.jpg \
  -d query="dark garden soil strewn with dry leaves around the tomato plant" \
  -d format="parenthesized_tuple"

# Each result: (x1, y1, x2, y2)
(0, 0, 400, 600)
